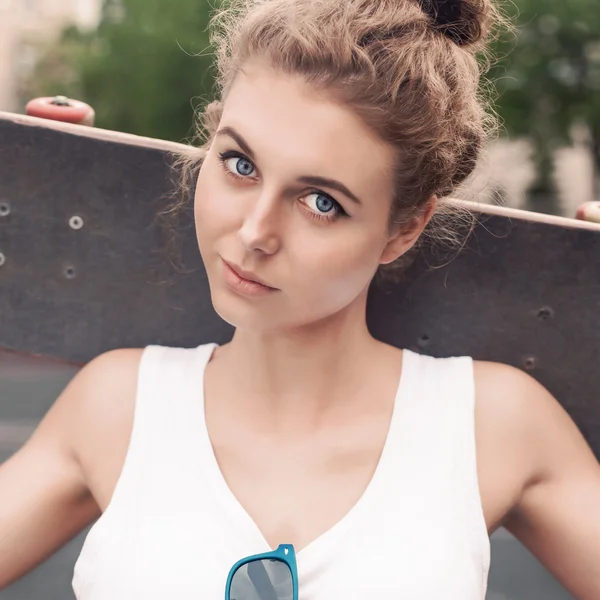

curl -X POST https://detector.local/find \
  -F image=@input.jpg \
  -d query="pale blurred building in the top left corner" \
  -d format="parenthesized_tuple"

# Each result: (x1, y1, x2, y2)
(0, 0, 101, 111)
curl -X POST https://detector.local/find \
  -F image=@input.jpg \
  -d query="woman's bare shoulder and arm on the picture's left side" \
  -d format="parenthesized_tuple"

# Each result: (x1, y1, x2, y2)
(0, 350, 141, 589)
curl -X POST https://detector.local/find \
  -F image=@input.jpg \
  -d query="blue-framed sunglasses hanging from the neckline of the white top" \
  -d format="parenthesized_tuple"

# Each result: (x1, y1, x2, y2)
(225, 544, 298, 600)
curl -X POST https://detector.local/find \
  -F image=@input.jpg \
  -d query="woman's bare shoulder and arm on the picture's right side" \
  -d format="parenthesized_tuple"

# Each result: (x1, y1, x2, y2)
(475, 363, 600, 600)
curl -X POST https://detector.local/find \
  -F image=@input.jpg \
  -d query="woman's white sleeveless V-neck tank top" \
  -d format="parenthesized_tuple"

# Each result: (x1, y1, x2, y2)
(73, 344, 490, 600)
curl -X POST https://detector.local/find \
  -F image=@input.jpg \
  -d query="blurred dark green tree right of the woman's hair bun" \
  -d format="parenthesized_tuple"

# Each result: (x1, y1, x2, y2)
(490, 0, 600, 202)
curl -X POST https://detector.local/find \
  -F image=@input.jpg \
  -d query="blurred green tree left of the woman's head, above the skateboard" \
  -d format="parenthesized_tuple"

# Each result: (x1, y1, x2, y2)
(21, 0, 213, 141)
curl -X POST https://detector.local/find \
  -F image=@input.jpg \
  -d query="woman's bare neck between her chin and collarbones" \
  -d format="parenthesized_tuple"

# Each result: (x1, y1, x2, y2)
(215, 294, 380, 420)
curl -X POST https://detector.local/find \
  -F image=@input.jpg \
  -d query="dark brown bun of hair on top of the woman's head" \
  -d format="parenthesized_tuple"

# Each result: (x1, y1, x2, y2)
(419, 0, 490, 46)
